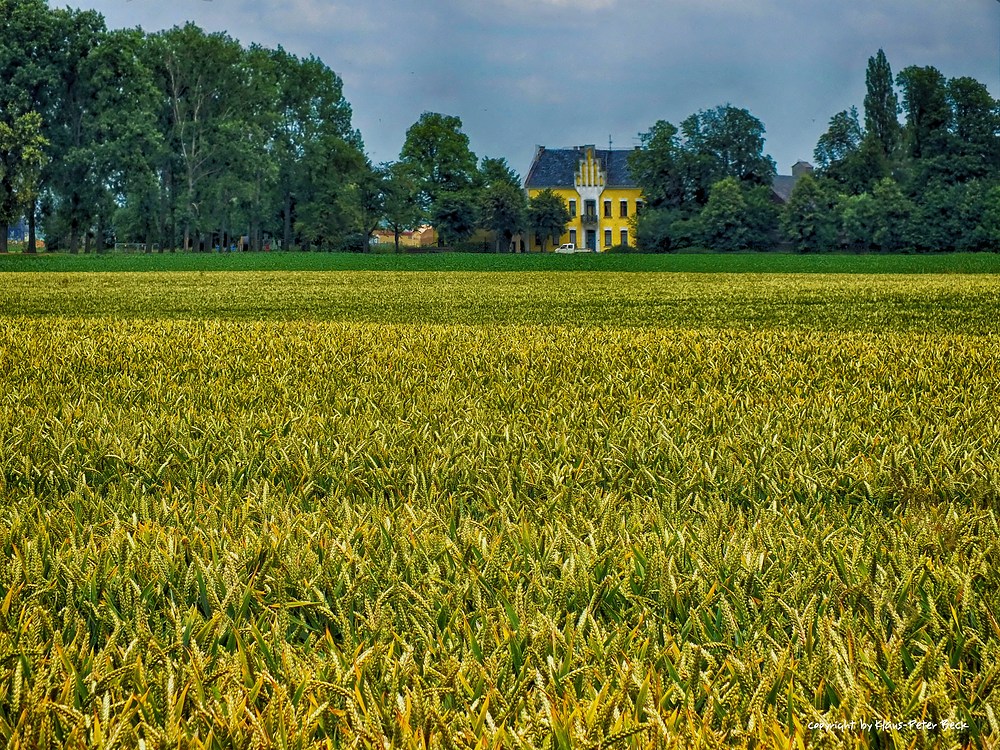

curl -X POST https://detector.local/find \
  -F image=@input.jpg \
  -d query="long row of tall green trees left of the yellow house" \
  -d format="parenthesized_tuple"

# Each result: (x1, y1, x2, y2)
(0, 0, 544, 253)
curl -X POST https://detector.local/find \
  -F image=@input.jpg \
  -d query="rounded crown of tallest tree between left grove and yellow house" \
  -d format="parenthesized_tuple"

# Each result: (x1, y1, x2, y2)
(399, 112, 476, 211)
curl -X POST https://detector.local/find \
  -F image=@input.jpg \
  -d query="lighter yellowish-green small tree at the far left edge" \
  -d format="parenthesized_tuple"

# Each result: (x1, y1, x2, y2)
(0, 112, 46, 253)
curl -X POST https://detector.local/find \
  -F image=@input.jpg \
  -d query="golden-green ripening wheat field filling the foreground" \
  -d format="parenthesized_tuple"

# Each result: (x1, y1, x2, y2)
(0, 274, 1000, 750)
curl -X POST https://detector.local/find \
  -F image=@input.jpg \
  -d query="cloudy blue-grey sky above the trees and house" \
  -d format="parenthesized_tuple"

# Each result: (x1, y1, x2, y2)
(70, 0, 1000, 176)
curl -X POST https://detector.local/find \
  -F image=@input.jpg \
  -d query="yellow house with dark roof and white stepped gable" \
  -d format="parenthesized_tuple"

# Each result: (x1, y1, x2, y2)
(524, 146, 642, 252)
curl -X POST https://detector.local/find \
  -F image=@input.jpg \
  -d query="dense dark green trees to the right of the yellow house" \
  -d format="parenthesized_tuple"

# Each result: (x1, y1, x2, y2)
(630, 50, 1000, 252)
